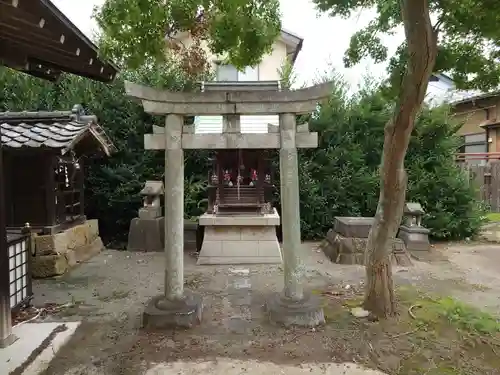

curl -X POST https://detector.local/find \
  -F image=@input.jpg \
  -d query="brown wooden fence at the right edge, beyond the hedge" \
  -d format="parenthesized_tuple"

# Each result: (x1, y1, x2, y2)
(462, 162, 500, 212)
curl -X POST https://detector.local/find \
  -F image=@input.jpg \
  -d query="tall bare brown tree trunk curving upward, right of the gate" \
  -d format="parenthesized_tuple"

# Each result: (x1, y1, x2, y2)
(363, 0, 437, 318)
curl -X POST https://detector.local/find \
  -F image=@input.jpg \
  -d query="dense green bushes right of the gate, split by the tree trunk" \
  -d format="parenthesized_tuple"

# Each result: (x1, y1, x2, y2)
(299, 82, 484, 240)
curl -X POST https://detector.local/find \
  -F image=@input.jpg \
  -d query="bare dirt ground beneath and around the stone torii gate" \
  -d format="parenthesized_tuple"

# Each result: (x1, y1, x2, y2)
(34, 243, 500, 375)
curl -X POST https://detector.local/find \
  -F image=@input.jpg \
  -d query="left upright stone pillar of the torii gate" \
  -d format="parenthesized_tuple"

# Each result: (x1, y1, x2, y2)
(165, 114, 184, 301)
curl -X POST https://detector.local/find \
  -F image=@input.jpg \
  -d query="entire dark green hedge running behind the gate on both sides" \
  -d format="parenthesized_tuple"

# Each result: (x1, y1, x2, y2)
(0, 66, 483, 247)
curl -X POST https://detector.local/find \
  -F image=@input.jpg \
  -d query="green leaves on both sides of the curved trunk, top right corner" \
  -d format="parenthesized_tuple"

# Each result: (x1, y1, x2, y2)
(313, 0, 500, 91)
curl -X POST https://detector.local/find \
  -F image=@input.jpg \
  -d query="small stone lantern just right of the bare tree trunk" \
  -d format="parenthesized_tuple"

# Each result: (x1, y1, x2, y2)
(398, 202, 431, 259)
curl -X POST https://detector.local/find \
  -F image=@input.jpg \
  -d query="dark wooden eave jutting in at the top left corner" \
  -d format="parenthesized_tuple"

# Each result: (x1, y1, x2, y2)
(0, 0, 118, 82)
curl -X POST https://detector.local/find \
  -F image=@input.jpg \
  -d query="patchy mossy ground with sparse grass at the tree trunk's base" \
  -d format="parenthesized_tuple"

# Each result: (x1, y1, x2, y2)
(325, 287, 500, 375)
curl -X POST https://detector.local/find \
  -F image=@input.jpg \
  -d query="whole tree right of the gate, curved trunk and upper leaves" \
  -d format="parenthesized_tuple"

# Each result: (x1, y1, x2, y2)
(313, 0, 500, 318)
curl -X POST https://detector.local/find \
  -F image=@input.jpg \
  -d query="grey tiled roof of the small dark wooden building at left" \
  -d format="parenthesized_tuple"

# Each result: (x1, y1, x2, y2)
(0, 105, 116, 156)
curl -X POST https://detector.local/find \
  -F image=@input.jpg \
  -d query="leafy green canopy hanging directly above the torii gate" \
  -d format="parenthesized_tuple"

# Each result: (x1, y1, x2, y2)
(94, 0, 281, 73)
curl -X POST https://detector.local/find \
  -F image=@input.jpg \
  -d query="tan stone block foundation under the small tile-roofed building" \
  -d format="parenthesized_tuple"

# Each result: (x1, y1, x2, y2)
(31, 220, 104, 278)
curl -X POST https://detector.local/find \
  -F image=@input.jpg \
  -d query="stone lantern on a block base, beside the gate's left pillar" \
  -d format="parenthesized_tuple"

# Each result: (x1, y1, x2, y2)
(127, 181, 165, 251)
